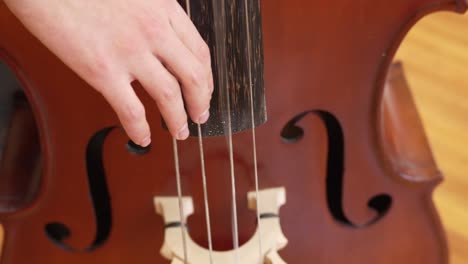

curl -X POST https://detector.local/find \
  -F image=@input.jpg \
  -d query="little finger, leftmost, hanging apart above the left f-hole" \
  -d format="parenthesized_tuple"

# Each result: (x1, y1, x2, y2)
(100, 80, 151, 147)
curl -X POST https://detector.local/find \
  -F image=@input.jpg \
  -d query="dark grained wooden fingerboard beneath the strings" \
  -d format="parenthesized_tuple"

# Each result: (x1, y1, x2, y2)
(179, 0, 267, 137)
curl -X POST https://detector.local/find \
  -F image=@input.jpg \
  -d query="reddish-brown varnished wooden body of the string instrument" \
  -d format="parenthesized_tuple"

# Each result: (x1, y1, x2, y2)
(0, 0, 466, 264)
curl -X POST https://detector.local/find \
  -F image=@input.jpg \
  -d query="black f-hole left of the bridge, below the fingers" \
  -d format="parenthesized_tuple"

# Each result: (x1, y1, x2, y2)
(45, 128, 113, 252)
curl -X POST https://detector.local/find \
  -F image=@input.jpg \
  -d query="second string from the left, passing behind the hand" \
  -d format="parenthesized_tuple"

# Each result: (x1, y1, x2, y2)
(186, 0, 214, 264)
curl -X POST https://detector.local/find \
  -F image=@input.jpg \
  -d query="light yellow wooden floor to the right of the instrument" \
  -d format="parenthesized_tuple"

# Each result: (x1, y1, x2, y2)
(396, 9, 468, 264)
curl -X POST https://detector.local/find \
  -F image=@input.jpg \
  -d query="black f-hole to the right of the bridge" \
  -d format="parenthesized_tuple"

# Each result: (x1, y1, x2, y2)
(281, 110, 392, 228)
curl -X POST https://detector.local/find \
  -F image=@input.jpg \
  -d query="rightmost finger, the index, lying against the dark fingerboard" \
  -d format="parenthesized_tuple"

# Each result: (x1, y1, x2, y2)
(170, 1, 214, 96)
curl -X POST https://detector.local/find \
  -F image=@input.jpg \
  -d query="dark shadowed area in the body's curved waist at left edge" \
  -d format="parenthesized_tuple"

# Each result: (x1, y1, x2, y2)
(0, 57, 41, 213)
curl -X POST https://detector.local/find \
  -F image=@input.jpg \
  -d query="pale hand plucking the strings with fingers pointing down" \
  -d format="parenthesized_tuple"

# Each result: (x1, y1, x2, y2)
(5, 0, 213, 146)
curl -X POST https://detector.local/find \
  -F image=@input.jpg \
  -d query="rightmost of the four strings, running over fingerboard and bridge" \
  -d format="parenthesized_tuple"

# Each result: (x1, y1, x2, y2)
(244, 0, 263, 263)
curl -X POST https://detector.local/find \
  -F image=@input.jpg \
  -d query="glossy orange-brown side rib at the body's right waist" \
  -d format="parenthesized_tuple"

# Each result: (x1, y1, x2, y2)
(381, 62, 441, 182)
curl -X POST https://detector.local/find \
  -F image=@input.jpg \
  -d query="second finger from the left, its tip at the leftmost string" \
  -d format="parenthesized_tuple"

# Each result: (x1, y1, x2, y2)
(133, 54, 189, 140)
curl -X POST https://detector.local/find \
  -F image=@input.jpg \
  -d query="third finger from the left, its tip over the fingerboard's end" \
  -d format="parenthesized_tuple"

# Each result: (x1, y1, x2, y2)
(155, 26, 212, 123)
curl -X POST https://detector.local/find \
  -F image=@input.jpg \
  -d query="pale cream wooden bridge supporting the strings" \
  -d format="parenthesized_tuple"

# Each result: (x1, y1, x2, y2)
(154, 188, 288, 264)
